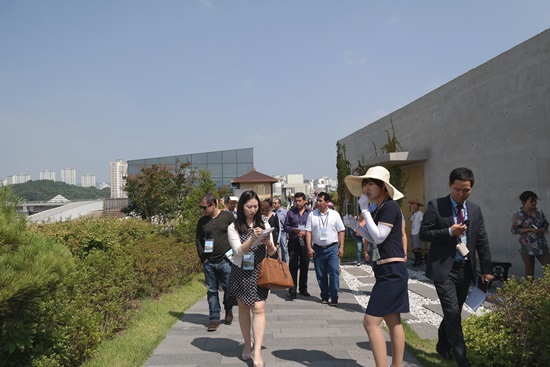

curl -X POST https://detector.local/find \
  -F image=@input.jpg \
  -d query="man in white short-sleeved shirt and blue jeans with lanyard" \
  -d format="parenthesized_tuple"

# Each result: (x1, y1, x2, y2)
(306, 192, 346, 306)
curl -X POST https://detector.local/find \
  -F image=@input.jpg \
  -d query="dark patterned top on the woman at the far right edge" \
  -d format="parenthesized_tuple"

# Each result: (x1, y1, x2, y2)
(512, 208, 548, 256)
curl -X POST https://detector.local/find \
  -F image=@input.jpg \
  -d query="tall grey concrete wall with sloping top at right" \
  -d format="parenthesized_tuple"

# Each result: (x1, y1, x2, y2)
(339, 29, 550, 276)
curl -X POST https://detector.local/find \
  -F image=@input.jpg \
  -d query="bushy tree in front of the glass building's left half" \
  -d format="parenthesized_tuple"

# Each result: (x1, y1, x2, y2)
(123, 162, 197, 226)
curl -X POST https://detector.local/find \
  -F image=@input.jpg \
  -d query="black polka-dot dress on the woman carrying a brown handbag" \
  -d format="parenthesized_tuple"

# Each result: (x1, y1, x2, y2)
(229, 228, 269, 306)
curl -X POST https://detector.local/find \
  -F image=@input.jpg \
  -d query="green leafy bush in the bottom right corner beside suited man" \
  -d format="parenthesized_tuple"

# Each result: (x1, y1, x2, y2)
(464, 266, 550, 367)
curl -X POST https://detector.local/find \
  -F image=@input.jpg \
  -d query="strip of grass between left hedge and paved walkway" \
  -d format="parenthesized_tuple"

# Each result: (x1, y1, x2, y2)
(83, 273, 206, 367)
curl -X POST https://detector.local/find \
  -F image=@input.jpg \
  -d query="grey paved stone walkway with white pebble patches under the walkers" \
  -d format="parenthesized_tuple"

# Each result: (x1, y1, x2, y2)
(145, 264, 494, 367)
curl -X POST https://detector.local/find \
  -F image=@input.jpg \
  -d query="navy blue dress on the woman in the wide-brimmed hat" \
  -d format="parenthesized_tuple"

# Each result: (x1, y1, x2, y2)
(365, 199, 409, 317)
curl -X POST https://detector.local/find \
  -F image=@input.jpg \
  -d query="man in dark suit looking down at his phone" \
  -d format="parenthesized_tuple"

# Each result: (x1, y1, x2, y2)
(420, 167, 493, 366)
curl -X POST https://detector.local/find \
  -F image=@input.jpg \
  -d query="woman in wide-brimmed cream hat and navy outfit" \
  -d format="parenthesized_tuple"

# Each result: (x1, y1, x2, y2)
(344, 166, 409, 367)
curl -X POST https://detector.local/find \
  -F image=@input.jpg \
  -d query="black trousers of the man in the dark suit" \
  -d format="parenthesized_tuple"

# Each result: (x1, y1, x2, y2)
(434, 261, 472, 366)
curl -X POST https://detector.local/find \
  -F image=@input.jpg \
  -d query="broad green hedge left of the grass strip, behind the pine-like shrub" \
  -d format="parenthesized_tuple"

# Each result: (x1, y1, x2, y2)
(14, 215, 202, 367)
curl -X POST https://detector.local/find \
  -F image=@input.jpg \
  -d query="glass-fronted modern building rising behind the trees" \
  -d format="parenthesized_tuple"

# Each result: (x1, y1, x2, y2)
(127, 148, 254, 187)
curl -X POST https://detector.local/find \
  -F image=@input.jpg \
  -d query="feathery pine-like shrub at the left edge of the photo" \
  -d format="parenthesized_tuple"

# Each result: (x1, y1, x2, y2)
(0, 187, 74, 366)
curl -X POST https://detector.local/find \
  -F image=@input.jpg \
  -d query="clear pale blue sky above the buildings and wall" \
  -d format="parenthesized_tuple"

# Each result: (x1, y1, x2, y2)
(0, 0, 550, 183)
